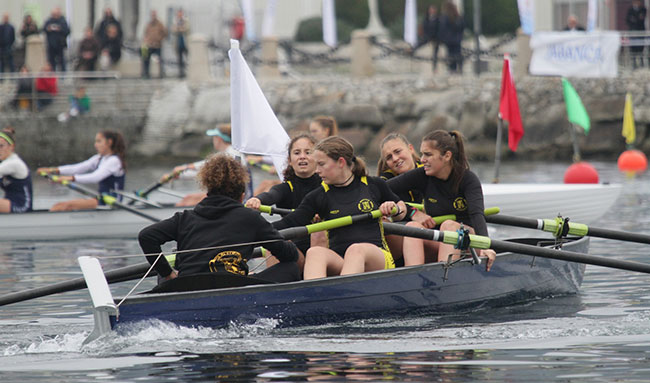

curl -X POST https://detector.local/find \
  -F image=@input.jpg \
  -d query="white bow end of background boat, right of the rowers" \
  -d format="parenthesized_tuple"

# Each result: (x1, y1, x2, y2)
(483, 184, 623, 224)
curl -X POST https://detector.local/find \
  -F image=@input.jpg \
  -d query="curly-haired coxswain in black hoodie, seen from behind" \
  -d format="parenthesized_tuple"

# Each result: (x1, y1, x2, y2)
(138, 154, 300, 282)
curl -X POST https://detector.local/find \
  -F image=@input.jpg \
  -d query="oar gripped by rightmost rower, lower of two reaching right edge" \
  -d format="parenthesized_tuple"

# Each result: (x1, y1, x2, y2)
(384, 223, 650, 274)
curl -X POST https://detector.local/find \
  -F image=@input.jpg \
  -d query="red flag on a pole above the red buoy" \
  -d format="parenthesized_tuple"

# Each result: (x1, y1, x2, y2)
(499, 55, 524, 152)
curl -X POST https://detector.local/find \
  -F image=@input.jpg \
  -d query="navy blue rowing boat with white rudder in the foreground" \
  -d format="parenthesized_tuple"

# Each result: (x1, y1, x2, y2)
(79, 237, 589, 340)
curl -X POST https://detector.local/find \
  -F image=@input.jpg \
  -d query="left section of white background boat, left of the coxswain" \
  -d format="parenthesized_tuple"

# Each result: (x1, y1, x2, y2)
(0, 206, 187, 241)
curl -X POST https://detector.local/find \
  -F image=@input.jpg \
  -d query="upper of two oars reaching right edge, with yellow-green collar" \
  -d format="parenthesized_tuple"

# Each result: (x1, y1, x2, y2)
(486, 215, 650, 244)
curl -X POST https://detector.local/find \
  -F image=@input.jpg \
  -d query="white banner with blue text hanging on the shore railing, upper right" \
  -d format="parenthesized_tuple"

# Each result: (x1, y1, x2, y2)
(529, 31, 621, 77)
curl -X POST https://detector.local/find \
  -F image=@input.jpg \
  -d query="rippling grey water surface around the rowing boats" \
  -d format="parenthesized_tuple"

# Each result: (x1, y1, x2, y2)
(0, 163, 650, 382)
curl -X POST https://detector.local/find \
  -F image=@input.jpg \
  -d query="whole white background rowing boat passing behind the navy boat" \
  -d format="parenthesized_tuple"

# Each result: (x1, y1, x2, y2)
(6, 184, 622, 241)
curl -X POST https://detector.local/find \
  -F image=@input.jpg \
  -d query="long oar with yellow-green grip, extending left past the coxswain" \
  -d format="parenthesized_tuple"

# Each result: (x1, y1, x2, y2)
(0, 210, 390, 306)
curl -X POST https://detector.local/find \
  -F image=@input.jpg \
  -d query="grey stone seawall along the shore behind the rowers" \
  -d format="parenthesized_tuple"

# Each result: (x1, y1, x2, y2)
(0, 72, 650, 167)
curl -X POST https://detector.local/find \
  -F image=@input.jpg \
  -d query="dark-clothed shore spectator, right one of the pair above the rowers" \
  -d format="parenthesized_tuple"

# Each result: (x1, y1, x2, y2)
(438, 1, 465, 73)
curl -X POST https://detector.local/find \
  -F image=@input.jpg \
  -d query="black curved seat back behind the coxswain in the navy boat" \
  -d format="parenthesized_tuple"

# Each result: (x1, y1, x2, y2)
(144, 272, 275, 294)
